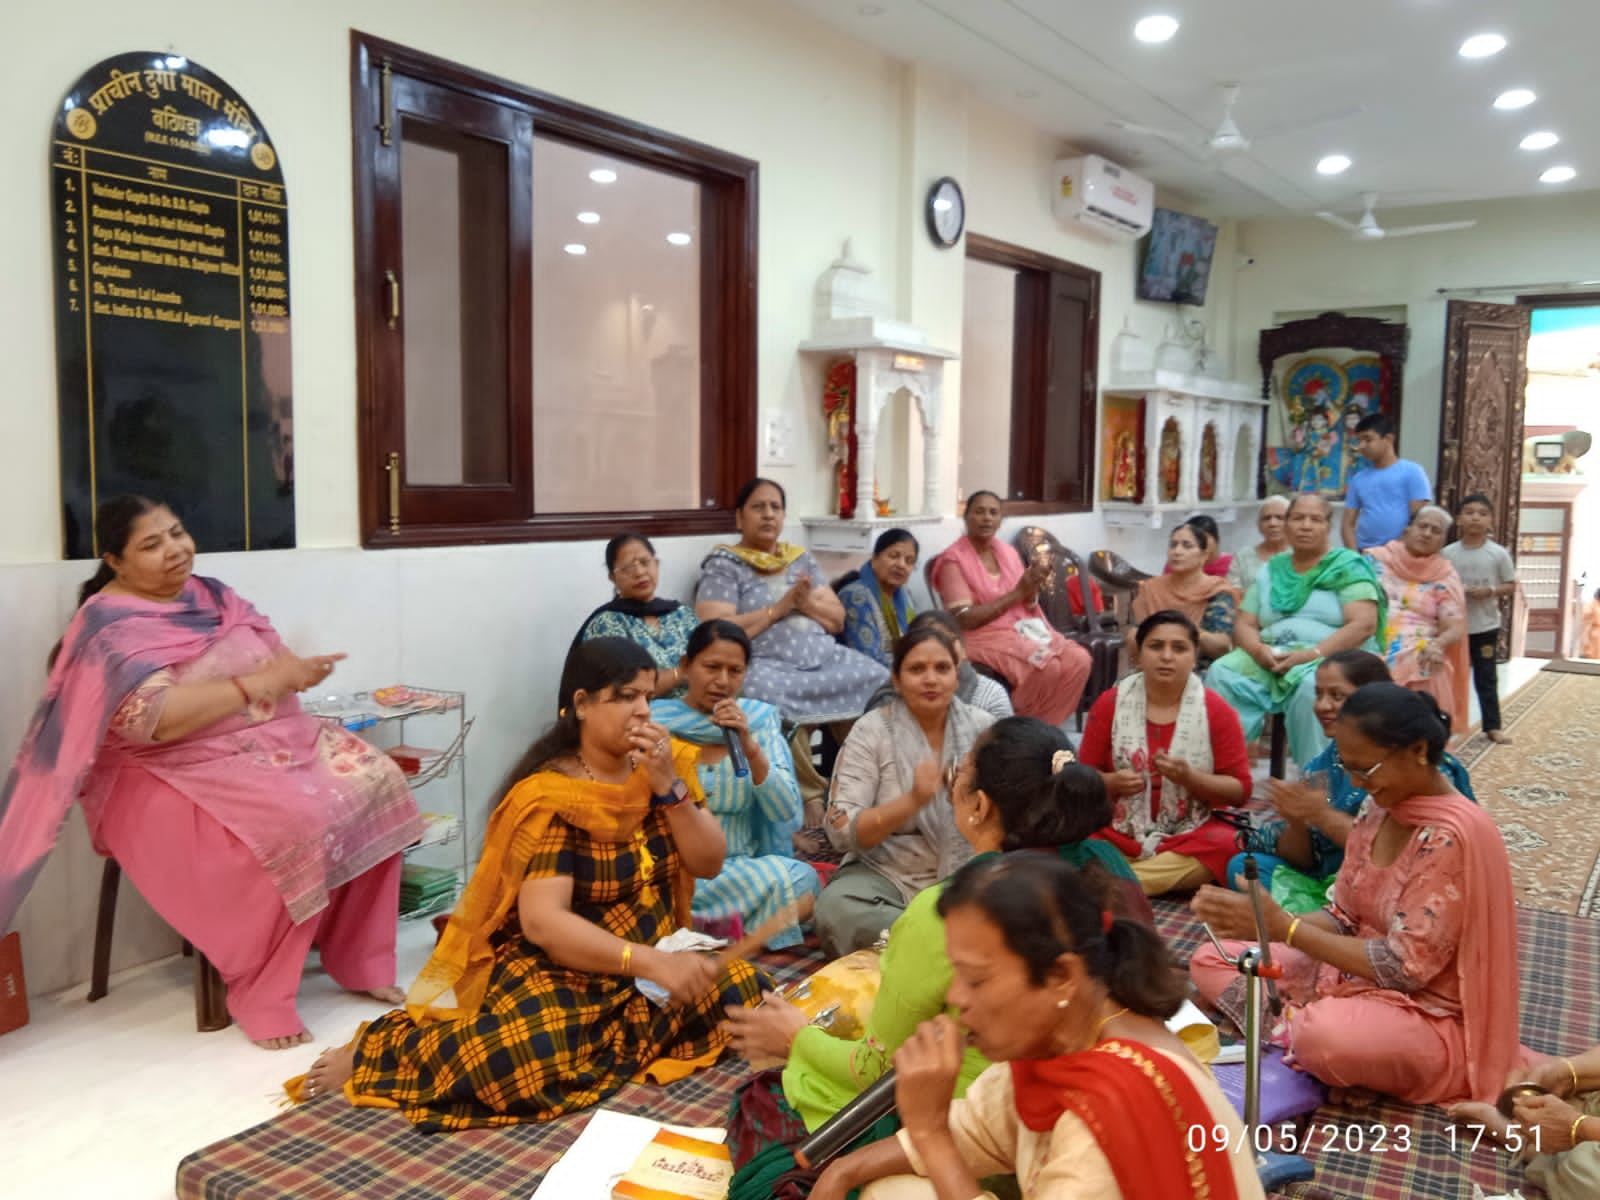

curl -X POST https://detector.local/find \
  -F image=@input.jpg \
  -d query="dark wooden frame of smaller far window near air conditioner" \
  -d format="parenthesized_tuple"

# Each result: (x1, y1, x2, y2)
(966, 234, 1101, 517)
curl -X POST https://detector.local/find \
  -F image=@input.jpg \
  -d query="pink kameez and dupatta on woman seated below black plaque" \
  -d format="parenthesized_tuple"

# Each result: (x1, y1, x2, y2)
(0, 576, 422, 930)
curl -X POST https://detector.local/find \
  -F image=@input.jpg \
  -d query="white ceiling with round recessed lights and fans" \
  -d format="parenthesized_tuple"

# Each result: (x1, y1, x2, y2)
(787, 0, 1600, 218)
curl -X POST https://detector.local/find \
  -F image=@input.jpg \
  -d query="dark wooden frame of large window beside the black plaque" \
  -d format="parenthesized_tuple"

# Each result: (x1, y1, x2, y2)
(350, 30, 758, 549)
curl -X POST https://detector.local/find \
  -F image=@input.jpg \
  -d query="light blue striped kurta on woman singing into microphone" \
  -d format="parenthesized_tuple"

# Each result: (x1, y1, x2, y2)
(653, 699, 821, 950)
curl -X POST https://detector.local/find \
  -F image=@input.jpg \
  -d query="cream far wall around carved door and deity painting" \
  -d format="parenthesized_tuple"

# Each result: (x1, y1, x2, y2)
(1234, 192, 1600, 477)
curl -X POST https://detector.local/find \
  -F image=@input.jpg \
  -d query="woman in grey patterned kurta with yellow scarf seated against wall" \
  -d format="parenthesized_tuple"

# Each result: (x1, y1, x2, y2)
(694, 478, 888, 725)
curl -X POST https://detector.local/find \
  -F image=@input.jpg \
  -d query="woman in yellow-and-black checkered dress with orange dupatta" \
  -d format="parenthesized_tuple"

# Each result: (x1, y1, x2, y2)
(306, 638, 763, 1130)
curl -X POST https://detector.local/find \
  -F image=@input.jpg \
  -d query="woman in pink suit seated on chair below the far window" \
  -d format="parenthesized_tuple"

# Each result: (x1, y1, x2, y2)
(933, 491, 1090, 725)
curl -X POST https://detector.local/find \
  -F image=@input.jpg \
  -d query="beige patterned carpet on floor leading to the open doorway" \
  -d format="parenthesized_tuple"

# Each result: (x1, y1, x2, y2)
(1458, 672, 1600, 917)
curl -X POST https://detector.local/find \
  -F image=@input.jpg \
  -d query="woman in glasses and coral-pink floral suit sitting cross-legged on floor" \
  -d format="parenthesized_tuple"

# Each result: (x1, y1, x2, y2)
(1189, 683, 1528, 1104)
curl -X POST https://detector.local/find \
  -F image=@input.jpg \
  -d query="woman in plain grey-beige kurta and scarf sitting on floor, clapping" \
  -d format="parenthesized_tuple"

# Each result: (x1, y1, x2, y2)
(816, 626, 994, 955)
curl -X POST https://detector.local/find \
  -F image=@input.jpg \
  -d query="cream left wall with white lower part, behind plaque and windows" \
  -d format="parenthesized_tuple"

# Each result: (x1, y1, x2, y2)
(0, 0, 1232, 992)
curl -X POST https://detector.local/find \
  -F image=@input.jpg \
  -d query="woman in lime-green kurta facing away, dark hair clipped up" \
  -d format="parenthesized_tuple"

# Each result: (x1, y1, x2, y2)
(728, 717, 1150, 1130)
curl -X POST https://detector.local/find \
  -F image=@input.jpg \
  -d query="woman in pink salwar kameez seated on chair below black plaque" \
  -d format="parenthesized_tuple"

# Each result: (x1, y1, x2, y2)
(0, 498, 422, 1050)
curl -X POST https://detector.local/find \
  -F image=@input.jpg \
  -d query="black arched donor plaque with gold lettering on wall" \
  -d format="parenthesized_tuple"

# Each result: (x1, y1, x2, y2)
(50, 51, 294, 558)
